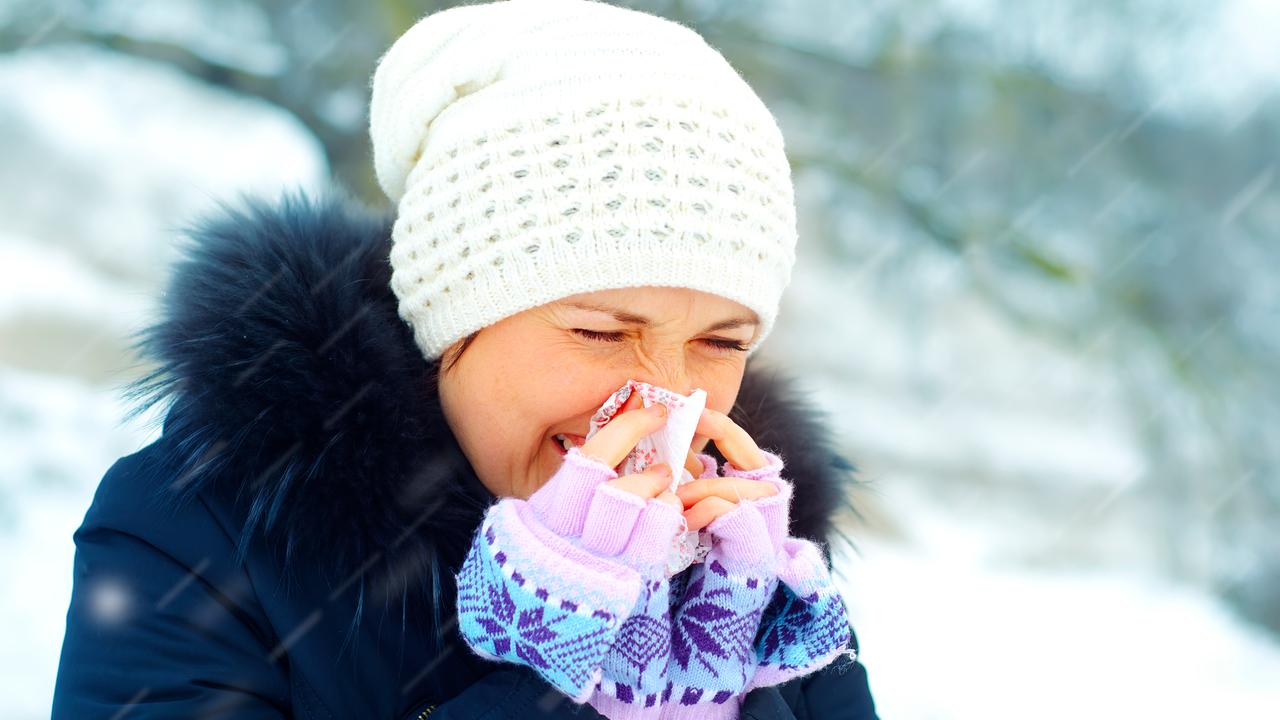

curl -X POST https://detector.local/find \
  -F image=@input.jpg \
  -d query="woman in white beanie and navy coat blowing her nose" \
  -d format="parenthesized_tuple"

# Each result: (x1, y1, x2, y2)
(52, 0, 876, 719)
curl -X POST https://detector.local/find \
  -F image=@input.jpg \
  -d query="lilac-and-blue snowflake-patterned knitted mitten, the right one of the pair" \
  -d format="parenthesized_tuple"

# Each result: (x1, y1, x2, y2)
(662, 451, 850, 717)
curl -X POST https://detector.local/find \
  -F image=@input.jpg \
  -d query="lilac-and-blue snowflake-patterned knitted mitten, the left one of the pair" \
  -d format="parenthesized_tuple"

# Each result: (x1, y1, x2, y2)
(457, 448, 684, 703)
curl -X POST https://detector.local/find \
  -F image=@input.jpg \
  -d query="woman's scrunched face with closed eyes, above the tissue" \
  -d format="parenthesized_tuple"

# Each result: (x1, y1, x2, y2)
(439, 287, 758, 498)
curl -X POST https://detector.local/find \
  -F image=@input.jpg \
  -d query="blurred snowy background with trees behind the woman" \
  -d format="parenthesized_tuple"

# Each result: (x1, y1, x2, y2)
(0, 0, 1280, 720)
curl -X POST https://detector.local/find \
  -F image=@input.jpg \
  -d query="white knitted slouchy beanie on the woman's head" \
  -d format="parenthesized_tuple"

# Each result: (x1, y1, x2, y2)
(370, 0, 796, 360)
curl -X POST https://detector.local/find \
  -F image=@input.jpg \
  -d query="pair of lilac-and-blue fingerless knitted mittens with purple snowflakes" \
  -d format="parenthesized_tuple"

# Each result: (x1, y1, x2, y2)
(458, 448, 850, 720)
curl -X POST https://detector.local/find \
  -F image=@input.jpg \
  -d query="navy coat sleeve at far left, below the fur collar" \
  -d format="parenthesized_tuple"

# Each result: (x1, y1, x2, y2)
(51, 427, 291, 719)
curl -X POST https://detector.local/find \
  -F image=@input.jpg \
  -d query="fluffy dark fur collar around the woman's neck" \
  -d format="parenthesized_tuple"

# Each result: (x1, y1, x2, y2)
(127, 188, 854, 602)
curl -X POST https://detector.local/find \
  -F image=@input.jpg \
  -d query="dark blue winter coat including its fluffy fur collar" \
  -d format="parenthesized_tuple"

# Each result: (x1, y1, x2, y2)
(52, 191, 876, 720)
